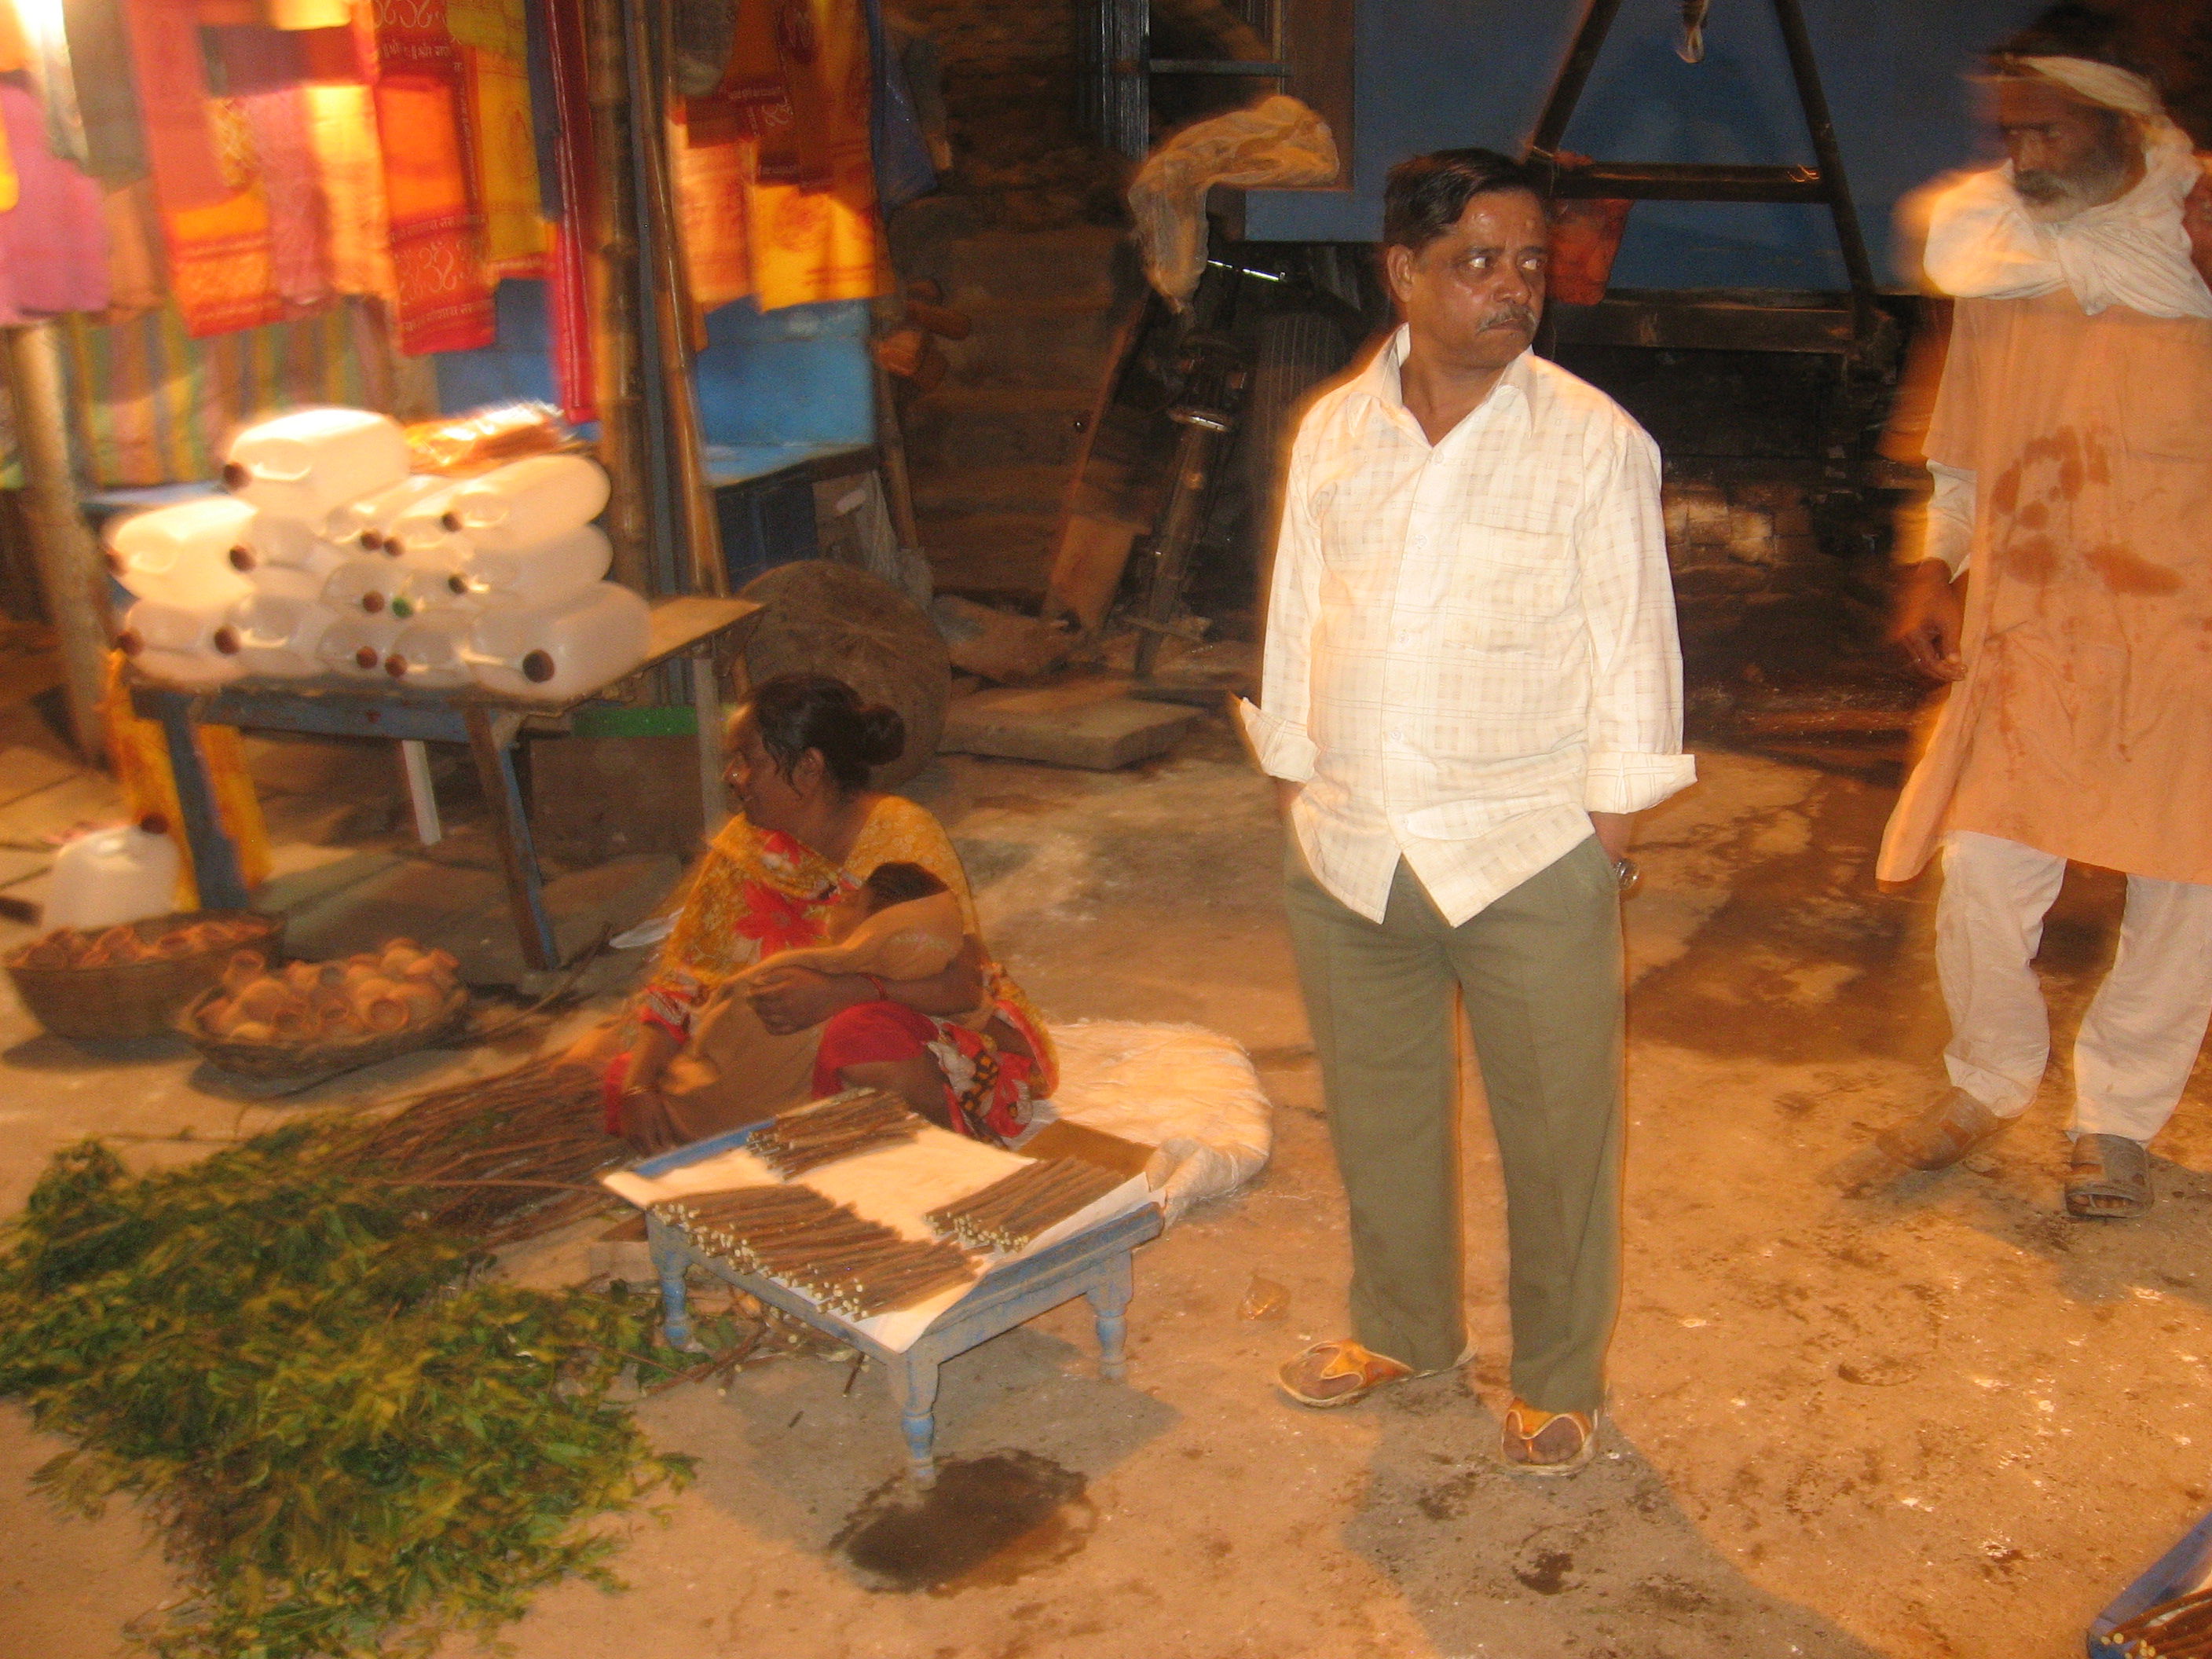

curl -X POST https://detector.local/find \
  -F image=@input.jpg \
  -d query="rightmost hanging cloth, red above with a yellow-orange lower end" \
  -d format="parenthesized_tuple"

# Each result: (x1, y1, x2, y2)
(739, 0, 892, 312)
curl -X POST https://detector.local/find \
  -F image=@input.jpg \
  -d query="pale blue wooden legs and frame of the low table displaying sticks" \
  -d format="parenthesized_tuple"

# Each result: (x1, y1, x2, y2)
(635, 1124, 1166, 1486)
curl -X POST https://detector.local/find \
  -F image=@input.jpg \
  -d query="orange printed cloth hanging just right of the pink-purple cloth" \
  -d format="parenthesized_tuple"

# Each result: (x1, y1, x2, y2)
(126, 0, 283, 334)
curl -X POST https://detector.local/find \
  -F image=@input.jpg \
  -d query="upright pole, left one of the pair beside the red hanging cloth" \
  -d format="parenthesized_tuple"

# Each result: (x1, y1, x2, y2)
(584, 0, 655, 595)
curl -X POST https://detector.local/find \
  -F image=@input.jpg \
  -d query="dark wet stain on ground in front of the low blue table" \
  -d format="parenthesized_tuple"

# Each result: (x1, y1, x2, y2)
(830, 1451, 1097, 1595)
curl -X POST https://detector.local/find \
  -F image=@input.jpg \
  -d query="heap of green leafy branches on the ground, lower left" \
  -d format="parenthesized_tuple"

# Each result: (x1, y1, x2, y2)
(0, 1126, 688, 1659)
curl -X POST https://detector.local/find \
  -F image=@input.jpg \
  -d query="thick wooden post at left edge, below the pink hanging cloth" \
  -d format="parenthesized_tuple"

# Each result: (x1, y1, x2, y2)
(6, 323, 108, 764)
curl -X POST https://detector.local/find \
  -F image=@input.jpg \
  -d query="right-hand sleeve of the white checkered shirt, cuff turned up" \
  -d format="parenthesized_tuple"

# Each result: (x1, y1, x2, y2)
(1575, 427, 1697, 811)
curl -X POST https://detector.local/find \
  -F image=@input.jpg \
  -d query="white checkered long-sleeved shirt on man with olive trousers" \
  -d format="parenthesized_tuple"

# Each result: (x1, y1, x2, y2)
(1243, 328, 1697, 927)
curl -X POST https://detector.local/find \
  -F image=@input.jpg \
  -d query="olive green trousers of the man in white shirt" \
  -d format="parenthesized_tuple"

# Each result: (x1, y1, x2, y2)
(1285, 838, 1621, 1412)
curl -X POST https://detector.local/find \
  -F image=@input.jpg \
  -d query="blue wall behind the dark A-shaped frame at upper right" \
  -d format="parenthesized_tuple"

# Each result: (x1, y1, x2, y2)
(1247, 0, 2044, 287)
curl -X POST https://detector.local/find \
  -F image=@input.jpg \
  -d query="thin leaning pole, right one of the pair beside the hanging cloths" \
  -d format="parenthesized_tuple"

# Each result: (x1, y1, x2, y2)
(628, 0, 730, 595)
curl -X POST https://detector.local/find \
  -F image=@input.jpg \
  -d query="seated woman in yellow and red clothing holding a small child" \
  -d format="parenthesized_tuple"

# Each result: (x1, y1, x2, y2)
(597, 675, 1057, 1150)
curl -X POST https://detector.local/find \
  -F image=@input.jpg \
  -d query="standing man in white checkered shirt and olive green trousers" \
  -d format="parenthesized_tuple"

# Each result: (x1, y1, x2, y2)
(1243, 150, 1694, 1475)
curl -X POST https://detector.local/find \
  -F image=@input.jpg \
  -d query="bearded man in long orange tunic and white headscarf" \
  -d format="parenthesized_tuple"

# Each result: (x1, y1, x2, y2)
(1845, 6, 2212, 1217)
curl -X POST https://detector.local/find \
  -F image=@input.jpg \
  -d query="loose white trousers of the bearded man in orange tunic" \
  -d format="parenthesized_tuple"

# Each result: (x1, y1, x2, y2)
(1936, 832, 2212, 1141)
